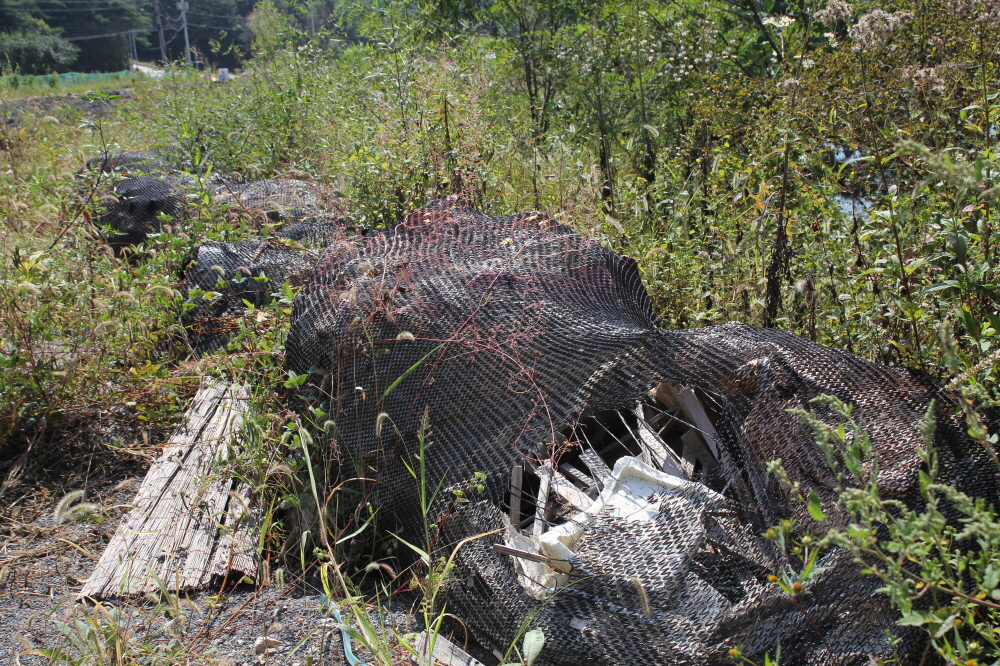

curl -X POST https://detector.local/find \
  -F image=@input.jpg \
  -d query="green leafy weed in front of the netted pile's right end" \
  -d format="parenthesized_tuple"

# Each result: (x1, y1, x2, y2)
(756, 376, 1000, 666)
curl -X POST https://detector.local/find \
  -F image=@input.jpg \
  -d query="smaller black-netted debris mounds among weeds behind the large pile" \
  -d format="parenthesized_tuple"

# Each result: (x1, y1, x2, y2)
(87, 149, 343, 354)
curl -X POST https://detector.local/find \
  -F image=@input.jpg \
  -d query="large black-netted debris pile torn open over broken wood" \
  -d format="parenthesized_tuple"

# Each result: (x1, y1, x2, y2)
(286, 197, 998, 665)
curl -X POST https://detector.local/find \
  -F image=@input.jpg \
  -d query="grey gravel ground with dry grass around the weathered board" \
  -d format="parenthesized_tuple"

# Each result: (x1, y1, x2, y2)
(0, 421, 412, 666)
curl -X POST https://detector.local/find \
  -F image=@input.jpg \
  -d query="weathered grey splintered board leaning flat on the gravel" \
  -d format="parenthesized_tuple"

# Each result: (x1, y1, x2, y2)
(80, 380, 260, 599)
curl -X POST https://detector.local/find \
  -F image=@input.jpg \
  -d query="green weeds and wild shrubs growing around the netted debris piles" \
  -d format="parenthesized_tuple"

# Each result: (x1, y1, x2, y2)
(0, 0, 1000, 664)
